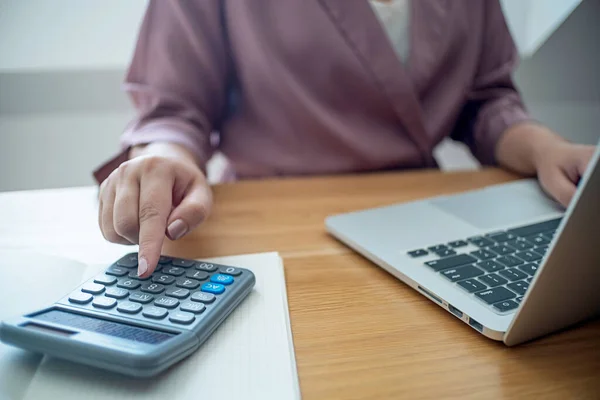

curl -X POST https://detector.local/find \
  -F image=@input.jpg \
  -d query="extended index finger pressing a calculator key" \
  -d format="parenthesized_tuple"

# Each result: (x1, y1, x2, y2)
(138, 170, 173, 277)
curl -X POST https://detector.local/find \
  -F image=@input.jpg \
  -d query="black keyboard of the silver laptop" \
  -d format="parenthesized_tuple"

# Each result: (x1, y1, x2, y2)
(408, 218, 561, 313)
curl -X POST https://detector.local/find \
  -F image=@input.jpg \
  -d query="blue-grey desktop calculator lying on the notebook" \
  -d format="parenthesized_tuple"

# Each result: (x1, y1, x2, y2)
(0, 253, 256, 378)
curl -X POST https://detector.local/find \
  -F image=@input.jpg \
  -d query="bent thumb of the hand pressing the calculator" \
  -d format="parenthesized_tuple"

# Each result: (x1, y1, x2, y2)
(166, 181, 212, 240)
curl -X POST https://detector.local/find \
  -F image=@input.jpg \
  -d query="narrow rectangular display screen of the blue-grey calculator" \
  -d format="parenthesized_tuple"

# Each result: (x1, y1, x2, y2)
(34, 310, 175, 344)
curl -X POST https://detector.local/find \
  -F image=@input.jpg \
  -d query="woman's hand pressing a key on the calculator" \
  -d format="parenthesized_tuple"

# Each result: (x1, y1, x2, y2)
(98, 143, 212, 277)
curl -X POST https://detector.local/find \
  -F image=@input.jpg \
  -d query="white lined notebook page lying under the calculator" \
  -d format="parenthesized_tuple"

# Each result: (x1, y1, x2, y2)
(25, 253, 299, 400)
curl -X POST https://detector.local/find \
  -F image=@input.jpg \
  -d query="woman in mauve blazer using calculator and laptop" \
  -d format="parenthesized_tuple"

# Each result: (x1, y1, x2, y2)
(96, 0, 593, 276)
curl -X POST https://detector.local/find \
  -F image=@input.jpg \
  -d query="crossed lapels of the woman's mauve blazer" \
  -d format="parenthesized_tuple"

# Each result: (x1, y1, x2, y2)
(319, 0, 450, 166)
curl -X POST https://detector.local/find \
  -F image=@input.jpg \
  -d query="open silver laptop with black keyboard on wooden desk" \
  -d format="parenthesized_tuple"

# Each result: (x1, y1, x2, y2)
(325, 142, 600, 346)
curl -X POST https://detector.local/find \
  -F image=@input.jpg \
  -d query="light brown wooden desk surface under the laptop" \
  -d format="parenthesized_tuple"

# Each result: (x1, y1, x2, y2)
(165, 170, 600, 399)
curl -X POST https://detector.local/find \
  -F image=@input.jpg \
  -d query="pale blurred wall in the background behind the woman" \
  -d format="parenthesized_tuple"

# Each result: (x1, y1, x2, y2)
(0, 0, 600, 191)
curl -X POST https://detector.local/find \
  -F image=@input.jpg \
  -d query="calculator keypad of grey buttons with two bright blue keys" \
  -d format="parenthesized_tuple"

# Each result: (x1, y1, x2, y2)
(61, 253, 244, 326)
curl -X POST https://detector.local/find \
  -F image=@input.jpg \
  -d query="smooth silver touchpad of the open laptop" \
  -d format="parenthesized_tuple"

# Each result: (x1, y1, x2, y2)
(431, 180, 564, 229)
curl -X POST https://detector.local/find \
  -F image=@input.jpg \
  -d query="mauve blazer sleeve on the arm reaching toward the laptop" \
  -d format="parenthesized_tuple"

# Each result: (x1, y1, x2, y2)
(451, 0, 531, 165)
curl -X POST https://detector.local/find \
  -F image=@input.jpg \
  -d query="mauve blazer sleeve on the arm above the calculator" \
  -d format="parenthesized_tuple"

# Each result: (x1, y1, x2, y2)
(94, 0, 231, 183)
